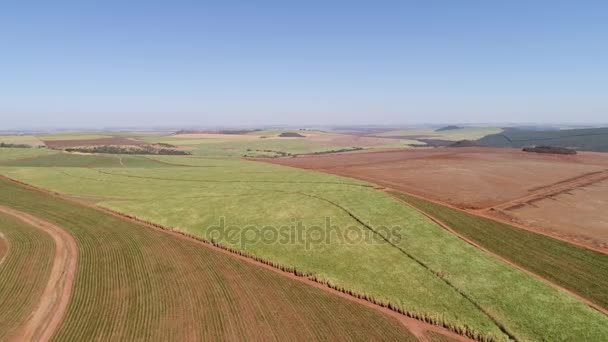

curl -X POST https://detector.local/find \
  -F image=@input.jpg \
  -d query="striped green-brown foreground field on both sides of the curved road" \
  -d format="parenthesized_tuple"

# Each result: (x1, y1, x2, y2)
(0, 180, 416, 341)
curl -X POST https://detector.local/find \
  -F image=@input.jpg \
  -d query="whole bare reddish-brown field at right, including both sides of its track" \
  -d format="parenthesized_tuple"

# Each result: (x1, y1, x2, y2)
(270, 147, 608, 248)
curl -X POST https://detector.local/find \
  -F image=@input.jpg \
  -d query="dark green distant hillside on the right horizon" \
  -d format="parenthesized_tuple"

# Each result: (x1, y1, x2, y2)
(477, 127, 608, 152)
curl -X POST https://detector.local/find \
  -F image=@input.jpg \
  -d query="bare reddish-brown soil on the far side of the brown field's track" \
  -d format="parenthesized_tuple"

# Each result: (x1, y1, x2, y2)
(269, 147, 608, 209)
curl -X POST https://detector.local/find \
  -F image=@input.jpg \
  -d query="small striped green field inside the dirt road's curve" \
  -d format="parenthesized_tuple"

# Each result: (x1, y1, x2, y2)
(0, 211, 55, 341)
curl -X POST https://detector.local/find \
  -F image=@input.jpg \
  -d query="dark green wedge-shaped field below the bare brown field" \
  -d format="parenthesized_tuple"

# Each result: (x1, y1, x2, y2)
(395, 193, 608, 308)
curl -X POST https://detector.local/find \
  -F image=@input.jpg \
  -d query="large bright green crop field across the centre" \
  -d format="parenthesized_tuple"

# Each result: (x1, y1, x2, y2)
(0, 150, 608, 340)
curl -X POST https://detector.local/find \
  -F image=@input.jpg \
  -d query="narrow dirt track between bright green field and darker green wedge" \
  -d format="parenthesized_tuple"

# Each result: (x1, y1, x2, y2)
(393, 194, 608, 316)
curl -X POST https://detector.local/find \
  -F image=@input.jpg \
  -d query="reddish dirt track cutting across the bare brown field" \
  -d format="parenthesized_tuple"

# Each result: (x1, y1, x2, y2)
(486, 170, 608, 213)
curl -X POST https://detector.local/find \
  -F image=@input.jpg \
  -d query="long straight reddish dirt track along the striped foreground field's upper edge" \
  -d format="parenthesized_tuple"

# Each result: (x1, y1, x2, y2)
(0, 175, 474, 341)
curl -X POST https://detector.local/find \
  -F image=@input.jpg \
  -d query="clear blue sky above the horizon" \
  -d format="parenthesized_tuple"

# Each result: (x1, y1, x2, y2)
(0, 0, 608, 129)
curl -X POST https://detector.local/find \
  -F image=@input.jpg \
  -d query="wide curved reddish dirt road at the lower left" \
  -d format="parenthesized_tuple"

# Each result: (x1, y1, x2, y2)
(0, 206, 78, 341)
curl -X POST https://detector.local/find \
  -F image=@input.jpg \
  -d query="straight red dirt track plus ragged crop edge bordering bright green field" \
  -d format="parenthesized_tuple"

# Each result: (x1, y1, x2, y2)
(0, 175, 476, 341)
